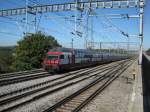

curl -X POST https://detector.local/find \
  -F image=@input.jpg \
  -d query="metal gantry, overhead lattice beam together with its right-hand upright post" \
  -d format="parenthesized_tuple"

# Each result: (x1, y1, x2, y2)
(0, 0, 145, 64)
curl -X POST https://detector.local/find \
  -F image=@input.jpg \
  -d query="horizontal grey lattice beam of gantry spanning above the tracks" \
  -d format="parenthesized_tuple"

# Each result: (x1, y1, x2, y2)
(0, 0, 140, 16)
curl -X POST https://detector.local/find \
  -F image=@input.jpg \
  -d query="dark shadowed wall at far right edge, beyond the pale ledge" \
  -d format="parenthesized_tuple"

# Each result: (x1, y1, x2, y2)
(142, 54, 150, 112)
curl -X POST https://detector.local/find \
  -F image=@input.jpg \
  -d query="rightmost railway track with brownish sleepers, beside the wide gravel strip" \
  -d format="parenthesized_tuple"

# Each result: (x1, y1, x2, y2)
(43, 59, 131, 112)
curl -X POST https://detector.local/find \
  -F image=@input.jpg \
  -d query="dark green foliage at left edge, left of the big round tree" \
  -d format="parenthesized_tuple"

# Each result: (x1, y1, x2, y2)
(0, 47, 14, 73)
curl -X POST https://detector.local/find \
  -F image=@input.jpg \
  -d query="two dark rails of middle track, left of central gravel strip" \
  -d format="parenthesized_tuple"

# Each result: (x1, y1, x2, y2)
(0, 59, 132, 111)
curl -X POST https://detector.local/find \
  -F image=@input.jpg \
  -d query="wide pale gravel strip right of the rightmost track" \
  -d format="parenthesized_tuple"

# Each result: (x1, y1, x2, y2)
(81, 60, 137, 112)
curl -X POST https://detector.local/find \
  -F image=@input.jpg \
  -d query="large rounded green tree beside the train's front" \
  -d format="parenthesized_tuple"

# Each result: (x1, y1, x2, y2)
(11, 32, 60, 71)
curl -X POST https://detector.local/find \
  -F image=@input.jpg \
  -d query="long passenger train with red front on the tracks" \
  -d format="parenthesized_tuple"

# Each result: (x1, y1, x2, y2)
(42, 47, 128, 71)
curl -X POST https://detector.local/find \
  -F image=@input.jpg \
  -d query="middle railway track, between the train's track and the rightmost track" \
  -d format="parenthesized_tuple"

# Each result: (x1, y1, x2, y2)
(0, 59, 129, 111)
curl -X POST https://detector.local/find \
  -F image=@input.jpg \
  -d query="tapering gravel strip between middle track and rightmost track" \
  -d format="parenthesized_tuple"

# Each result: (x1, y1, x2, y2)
(12, 75, 97, 112)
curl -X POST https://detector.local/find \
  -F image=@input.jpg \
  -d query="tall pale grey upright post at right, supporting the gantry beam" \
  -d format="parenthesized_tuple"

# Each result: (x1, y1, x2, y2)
(139, 0, 144, 64)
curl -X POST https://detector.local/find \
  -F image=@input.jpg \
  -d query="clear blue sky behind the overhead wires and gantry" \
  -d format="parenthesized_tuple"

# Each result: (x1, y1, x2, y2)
(0, 0, 150, 50)
